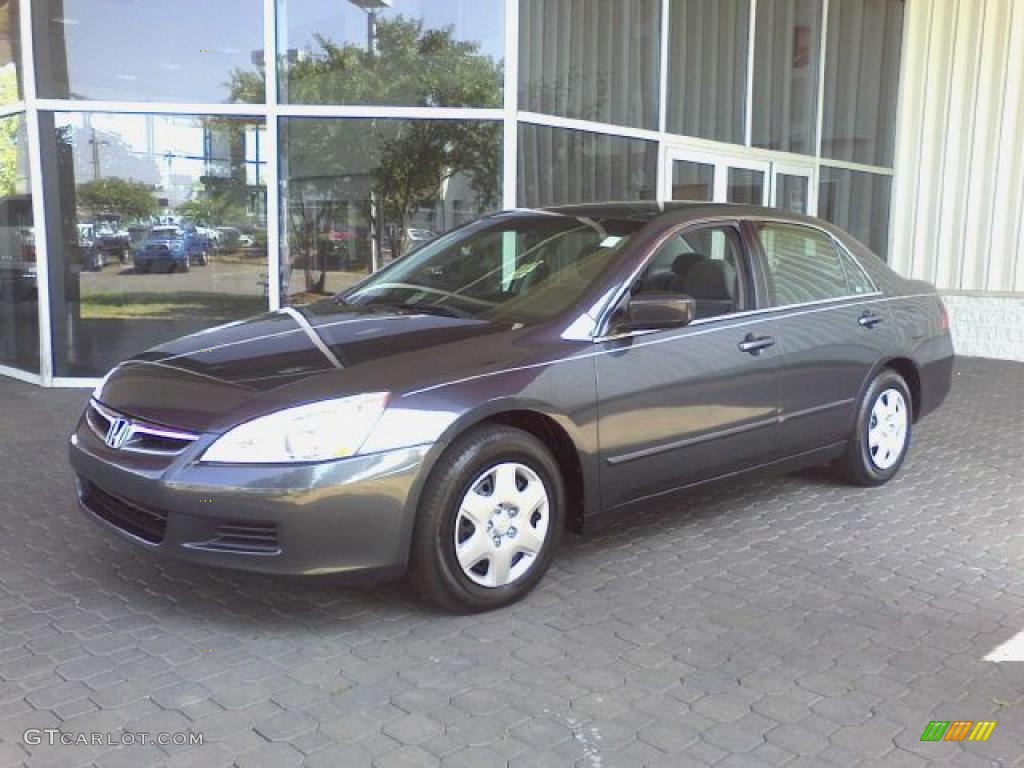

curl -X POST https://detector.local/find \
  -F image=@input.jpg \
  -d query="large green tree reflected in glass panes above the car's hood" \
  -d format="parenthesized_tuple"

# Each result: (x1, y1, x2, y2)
(231, 16, 503, 292)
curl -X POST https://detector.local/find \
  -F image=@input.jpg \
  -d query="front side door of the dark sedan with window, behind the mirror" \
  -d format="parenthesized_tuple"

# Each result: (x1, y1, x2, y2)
(596, 223, 779, 507)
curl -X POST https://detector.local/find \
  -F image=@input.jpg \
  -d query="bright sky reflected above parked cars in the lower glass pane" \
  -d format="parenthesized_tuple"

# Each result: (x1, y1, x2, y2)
(57, 113, 266, 206)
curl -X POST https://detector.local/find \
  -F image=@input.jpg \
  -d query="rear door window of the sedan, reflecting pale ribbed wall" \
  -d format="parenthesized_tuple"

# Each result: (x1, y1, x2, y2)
(758, 224, 871, 306)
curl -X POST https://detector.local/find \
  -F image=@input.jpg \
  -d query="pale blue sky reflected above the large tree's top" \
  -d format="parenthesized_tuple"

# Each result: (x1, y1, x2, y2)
(279, 0, 505, 61)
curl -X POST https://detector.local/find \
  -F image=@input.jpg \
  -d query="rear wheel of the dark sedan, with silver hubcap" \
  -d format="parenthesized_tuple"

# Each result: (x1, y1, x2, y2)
(838, 368, 913, 487)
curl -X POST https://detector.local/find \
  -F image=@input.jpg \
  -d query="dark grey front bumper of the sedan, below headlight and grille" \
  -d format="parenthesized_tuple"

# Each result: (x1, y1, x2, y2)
(70, 423, 429, 577)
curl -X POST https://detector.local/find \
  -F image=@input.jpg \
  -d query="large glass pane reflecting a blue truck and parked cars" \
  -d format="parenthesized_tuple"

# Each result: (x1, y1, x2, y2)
(42, 113, 271, 377)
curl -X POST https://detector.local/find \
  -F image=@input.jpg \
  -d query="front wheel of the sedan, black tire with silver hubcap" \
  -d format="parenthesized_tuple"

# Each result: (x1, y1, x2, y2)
(408, 426, 565, 613)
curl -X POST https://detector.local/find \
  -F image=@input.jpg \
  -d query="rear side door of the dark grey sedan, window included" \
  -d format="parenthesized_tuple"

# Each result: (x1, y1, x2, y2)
(746, 222, 893, 456)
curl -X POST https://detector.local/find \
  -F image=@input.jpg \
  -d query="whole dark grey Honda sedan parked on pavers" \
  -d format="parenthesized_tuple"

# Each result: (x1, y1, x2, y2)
(70, 203, 953, 611)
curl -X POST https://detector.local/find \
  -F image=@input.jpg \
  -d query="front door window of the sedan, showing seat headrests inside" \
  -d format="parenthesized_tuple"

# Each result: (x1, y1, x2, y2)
(633, 226, 750, 319)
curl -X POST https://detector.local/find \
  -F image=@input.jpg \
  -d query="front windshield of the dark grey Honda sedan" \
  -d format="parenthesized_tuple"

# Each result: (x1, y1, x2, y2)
(335, 214, 643, 322)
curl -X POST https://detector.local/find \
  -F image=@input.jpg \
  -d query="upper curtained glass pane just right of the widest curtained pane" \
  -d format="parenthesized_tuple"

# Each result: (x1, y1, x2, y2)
(668, 0, 751, 144)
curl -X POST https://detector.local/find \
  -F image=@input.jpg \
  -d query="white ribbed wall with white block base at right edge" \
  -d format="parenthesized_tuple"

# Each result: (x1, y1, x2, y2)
(890, 0, 1024, 360)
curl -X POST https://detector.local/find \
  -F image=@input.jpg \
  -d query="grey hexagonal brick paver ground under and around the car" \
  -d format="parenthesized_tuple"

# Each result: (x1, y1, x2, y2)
(0, 360, 1024, 768)
